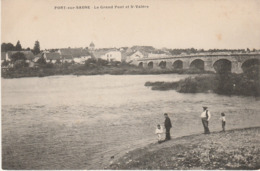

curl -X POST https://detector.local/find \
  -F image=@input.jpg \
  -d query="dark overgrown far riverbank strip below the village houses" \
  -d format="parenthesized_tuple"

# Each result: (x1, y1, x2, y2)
(2, 64, 211, 78)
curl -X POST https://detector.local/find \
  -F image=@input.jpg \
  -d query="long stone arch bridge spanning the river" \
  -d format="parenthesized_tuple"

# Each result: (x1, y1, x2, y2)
(132, 52, 260, 73)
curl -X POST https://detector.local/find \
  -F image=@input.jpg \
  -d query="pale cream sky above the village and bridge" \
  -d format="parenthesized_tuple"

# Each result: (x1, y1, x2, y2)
(1, 0, 260, 49)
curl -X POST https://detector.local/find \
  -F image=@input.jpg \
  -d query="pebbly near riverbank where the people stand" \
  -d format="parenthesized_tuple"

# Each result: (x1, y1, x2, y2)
(109, 127, 260, 170)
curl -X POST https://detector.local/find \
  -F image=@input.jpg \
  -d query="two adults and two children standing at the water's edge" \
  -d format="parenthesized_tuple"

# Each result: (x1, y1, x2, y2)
(155, 107, 226, 143)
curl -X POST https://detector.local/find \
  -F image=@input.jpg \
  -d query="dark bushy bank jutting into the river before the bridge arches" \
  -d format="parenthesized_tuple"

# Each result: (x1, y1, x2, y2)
(145, 67, 260, 96)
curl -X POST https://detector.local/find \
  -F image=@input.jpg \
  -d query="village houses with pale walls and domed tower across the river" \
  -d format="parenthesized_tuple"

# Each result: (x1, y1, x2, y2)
(1, 42, 175, 69)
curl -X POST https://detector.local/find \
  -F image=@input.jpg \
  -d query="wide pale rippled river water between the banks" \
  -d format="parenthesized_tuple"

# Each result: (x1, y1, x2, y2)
(2, 74, 260, 169)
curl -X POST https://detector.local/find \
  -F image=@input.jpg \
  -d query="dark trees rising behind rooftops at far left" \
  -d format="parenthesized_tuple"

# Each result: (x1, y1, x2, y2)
(1, 40, 41, 55)
